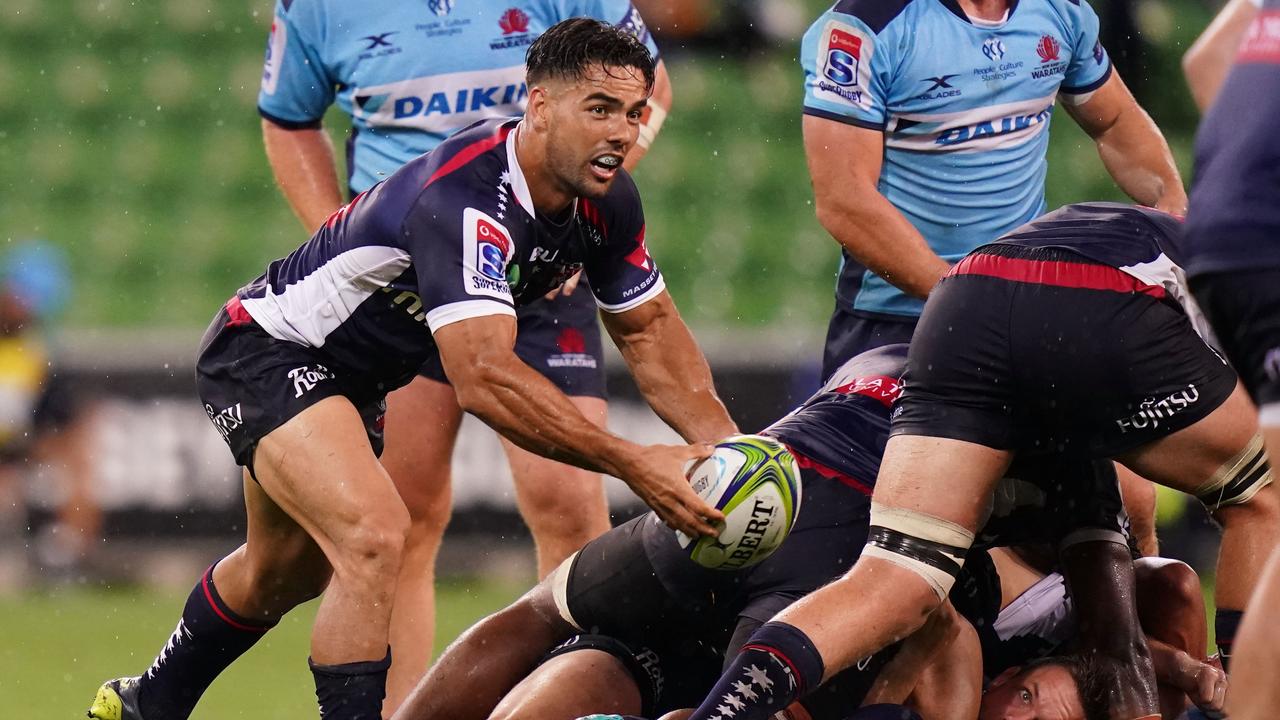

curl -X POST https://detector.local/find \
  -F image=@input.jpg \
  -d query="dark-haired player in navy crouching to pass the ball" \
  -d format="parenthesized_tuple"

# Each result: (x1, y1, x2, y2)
(90, 19, 735, 720)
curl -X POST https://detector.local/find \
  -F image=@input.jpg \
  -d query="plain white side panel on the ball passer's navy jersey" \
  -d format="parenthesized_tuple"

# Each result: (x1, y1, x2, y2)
(243, 245, 411, 347)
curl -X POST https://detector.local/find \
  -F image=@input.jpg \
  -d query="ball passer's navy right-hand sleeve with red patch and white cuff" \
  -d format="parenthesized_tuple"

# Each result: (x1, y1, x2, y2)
(579, 176, 667, 313)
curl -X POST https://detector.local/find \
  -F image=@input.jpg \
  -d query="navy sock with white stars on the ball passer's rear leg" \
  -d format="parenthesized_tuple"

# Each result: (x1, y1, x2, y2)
(138, 562, 274, 720)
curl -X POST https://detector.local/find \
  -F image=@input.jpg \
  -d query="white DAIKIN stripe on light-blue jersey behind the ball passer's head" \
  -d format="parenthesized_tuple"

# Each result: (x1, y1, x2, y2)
(352, 65, 527, 135)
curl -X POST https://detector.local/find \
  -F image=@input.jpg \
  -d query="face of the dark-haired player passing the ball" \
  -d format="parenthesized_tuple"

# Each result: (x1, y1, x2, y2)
(547, 67, 649, 197)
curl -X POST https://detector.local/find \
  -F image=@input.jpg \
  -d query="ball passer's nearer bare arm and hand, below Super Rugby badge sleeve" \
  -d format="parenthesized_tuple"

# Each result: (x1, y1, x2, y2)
(435, 315, 727, 536)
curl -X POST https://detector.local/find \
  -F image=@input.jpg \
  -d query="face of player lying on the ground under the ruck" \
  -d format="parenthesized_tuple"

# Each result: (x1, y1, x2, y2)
(978, 665, 1084, 720)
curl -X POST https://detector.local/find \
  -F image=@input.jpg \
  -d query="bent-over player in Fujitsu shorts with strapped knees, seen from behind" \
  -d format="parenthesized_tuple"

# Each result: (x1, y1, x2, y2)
(692, 204, 1280, 720)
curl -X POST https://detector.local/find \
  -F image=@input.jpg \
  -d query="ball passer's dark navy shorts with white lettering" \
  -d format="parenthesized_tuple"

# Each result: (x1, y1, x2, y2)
(196, 299, 387, 473)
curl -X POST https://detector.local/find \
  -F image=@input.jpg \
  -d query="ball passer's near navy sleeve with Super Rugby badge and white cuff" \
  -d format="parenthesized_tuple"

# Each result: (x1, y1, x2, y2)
(401, 192, 516, 333)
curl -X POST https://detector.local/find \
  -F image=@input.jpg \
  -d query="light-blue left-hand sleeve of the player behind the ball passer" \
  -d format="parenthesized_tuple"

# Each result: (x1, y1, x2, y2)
(257, 0, 335, 127)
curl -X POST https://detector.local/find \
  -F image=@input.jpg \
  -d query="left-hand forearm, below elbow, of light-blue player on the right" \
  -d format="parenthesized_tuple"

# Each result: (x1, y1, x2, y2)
(817, 188, 951, 299)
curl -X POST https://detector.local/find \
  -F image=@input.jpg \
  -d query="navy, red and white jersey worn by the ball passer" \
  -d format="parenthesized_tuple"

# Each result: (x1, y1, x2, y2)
(233, 119, 664, 389)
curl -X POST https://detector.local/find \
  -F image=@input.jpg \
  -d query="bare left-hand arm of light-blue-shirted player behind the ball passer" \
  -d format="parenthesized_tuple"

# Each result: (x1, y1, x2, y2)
(262, 119, 344, 232)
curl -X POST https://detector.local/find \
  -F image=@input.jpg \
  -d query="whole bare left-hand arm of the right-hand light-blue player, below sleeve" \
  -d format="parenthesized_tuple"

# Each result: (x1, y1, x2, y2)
(803, 115, 951, 297)
